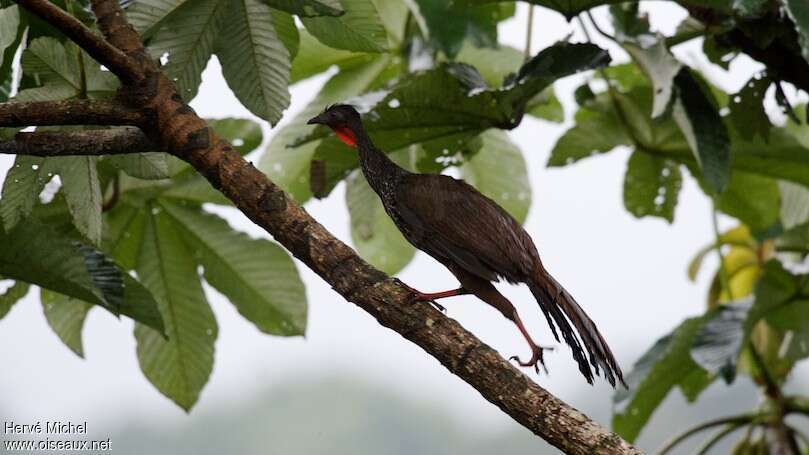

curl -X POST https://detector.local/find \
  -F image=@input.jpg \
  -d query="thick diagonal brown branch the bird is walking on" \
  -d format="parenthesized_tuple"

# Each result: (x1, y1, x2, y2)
(9, 0, 641, 454)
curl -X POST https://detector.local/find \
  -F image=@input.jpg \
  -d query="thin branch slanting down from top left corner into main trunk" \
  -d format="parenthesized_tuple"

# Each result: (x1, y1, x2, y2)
(16, 0, 143, 82)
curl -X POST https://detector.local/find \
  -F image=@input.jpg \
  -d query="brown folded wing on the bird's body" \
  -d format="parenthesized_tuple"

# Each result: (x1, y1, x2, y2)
(396, 174, 539, 282)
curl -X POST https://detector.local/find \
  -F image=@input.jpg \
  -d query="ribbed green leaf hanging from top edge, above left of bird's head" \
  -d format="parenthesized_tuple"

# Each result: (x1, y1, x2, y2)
(216, 0, 291, 125)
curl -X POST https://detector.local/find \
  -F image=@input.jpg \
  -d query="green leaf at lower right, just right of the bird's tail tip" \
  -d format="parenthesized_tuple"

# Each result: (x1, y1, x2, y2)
(612, 317, 710, 442)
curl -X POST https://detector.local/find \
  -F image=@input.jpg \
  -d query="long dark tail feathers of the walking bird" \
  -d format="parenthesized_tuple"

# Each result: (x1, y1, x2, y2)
(528, 268, 626, 387)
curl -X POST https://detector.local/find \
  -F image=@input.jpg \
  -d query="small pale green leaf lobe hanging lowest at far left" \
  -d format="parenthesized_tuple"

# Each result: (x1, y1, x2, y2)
(39, 289, 93, 358)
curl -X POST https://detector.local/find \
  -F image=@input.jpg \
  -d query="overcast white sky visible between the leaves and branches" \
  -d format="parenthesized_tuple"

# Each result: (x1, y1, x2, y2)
(0, 2, 808, 452)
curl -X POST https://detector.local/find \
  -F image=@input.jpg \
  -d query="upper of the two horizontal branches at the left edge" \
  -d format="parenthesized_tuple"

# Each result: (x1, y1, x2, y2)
(0, 100, 146, 127)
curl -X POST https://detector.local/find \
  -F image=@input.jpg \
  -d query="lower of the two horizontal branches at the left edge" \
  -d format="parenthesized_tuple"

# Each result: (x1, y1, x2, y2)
(0, 127, 152, 156)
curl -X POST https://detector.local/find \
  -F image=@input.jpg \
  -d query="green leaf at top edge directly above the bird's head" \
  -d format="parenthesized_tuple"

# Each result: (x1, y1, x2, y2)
(301, 0, 388, 52)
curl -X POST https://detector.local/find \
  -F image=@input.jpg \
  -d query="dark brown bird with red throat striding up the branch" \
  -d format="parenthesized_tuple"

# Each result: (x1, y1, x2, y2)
(307, 104, 626, 387)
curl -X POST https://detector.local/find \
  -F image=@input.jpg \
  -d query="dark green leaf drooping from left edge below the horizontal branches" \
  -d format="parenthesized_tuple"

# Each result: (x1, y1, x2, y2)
(0, 219, 163, 331)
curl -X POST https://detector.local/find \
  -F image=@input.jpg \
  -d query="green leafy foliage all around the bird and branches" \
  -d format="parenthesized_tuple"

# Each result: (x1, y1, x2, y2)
(0, 0, 809, 453)
